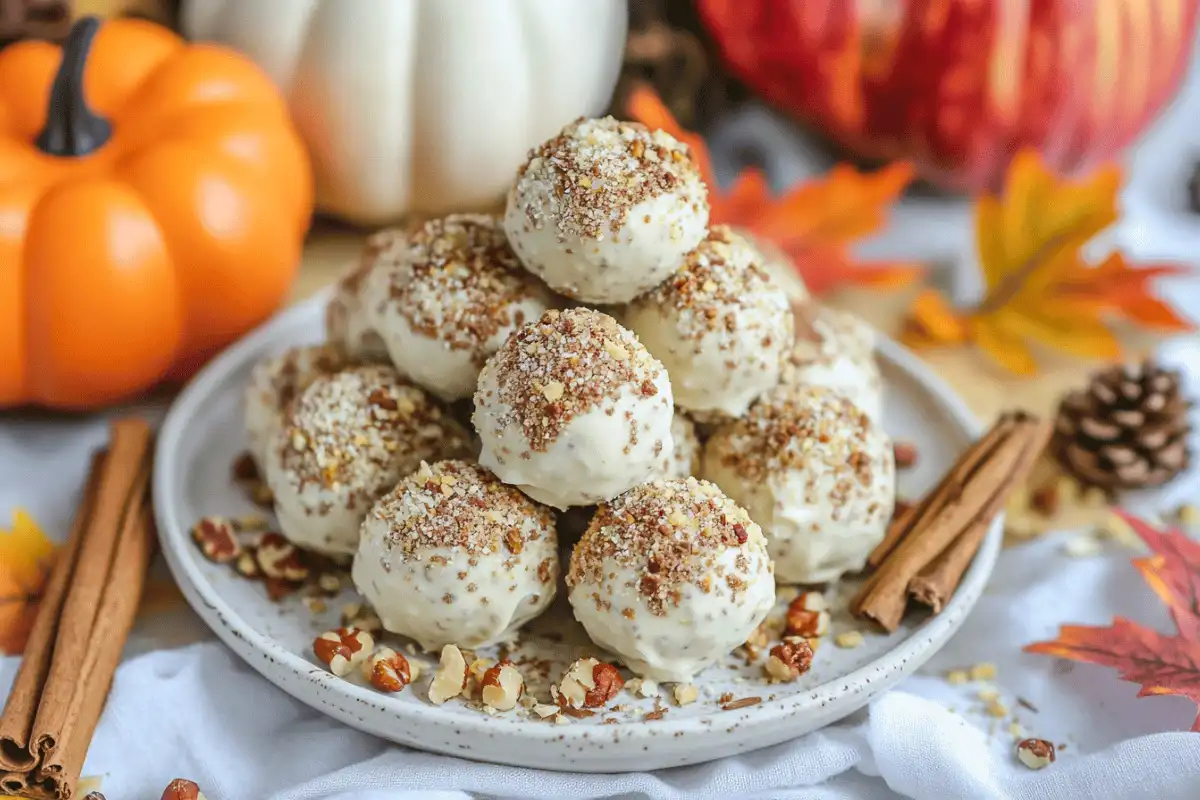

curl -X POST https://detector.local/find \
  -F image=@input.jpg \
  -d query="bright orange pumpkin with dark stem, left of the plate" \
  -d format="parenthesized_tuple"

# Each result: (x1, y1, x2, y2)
(0, 18, 313, 409)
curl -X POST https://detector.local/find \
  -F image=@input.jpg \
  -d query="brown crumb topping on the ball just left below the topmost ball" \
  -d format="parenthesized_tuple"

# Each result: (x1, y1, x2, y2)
(388, 213, 549, 366)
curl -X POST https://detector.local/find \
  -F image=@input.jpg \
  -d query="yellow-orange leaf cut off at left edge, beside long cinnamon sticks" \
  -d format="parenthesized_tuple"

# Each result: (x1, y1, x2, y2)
(0, 509, 54, 655)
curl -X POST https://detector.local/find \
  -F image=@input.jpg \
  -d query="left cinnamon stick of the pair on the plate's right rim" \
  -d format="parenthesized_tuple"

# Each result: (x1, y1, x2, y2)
(851, 415, 1048, 631)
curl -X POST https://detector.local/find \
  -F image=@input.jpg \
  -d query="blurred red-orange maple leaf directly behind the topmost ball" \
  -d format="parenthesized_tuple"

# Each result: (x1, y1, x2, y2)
(626, 86, 925, 295)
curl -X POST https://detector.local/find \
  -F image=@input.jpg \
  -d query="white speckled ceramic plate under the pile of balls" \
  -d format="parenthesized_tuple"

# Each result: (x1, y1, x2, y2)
(154, 291, 1001, 772)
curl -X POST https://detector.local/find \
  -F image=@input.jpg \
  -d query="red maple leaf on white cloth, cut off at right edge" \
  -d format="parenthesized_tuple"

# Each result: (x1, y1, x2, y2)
(1025, 513, 1200, 732)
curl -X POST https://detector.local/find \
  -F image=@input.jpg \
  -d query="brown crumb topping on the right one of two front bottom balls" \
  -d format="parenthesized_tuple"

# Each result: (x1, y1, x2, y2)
(566, 477, 766, 615)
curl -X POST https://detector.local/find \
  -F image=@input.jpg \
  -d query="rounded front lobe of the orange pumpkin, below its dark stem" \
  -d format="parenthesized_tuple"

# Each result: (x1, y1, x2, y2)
(20, 176, 180, 409)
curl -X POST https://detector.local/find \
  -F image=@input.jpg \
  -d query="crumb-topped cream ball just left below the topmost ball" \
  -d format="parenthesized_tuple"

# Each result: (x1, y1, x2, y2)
(366, 215, 554, 399)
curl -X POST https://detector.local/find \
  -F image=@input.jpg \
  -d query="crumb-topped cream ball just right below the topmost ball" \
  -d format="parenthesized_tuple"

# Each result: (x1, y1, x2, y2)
(623, 225, 793, 420)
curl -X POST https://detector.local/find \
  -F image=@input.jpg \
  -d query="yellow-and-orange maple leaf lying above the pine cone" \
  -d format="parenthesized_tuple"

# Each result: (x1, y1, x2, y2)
(902, 150, 1193, 375)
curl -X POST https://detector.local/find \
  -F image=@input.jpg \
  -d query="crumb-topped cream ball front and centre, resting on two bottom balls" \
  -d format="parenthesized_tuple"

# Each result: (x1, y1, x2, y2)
(473, 308, 674, 509)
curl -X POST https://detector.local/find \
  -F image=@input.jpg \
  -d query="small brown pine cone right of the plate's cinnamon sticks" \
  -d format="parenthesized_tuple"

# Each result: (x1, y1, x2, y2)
(1051, 361, 1192, 492)
